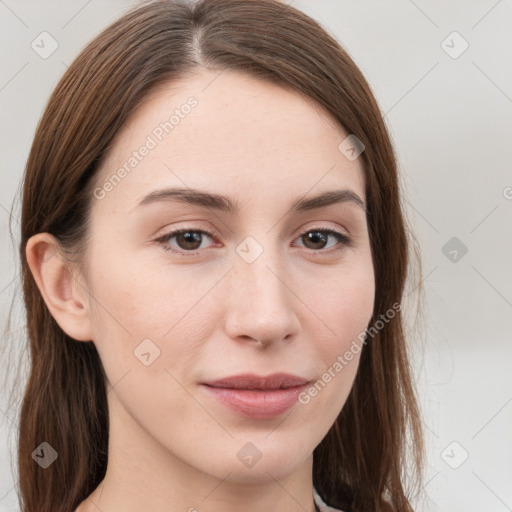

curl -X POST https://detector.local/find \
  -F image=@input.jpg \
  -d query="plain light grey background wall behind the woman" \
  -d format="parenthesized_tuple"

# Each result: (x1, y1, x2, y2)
(0, 0, 512, 512)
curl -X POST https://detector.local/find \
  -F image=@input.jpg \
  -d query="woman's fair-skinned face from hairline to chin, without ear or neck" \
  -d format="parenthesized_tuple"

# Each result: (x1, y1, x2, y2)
(84, 71, 375, 482)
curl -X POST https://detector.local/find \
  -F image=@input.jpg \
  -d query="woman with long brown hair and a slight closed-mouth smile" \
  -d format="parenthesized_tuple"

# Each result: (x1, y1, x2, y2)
(18, 0, 422, 512)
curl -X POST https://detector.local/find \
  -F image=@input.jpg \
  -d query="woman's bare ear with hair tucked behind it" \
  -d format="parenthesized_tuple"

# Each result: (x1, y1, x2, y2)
(25, 233, 92, 341)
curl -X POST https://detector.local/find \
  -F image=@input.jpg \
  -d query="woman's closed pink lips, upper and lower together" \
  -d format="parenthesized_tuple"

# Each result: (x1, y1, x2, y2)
(202, 373, 309, 419)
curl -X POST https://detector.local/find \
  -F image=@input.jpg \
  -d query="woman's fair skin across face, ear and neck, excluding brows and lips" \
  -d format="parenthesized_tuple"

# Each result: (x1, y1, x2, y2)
(27, 70, 375, 512)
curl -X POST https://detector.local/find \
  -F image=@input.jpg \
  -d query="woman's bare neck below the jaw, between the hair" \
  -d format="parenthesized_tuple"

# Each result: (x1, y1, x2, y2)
(76, 390, 316, 512)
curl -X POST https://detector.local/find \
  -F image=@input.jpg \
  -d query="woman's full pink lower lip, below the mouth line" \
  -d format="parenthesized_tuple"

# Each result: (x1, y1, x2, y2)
(203, 385, 306, 419)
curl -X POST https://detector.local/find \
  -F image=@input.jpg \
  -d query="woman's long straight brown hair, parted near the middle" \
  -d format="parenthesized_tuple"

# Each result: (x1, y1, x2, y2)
(18, 0, 423, 512)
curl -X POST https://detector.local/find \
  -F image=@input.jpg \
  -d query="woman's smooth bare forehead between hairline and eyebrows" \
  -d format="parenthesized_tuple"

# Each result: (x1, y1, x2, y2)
(91, 70, 364, 209)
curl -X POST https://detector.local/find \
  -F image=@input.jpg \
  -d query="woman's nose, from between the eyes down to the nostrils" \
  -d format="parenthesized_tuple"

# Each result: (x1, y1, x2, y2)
(225, 244, 301, 346)
